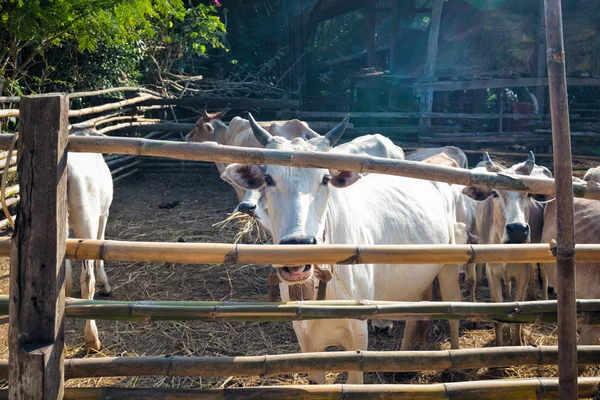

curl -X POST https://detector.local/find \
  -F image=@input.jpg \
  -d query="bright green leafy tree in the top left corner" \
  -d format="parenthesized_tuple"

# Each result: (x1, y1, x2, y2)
(0, 0, 225, 95)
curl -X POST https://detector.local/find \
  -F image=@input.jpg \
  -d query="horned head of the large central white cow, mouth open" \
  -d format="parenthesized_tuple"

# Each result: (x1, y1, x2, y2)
(221, 115, 352, 284)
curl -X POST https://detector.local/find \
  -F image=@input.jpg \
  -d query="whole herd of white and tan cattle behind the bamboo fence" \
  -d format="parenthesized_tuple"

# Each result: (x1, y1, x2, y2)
(67, 111, 600, 384)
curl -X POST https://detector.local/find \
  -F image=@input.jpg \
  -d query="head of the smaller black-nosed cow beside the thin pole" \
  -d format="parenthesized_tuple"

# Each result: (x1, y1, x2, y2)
(463, 152, 552, 243)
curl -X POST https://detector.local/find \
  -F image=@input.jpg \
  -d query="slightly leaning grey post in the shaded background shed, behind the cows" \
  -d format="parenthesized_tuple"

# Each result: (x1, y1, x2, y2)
(419, 0, 444, 126)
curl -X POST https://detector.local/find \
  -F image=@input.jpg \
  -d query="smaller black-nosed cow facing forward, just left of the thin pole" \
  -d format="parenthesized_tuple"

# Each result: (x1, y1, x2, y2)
(463, 152, 552, 346)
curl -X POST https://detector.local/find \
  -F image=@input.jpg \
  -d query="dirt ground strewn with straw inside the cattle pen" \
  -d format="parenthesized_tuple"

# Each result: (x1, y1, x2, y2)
(0, 169, 598, 388)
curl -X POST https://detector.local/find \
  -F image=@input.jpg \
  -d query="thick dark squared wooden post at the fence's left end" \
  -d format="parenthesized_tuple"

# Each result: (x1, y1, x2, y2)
(9, 94, 69, 400)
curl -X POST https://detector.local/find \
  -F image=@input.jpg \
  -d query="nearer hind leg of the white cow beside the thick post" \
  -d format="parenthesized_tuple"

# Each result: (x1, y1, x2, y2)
(72, 218, 101, 350)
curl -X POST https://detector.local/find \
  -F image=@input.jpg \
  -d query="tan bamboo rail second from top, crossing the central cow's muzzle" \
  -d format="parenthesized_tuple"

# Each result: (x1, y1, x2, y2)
(0, 238, 600, 266)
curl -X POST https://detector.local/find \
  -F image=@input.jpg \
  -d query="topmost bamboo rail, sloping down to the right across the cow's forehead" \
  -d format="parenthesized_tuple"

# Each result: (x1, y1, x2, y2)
(0, 135, 600, 200)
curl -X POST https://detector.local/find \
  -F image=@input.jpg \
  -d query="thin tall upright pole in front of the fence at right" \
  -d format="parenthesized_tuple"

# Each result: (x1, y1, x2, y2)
(545, 0, 577, 400)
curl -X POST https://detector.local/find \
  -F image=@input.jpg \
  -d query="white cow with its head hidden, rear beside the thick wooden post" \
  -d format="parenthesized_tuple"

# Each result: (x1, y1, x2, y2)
(65, 129, 113, 350)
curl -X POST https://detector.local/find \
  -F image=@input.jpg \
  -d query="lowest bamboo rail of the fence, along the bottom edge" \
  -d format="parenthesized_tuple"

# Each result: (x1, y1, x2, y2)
(0, 378, 600, 400)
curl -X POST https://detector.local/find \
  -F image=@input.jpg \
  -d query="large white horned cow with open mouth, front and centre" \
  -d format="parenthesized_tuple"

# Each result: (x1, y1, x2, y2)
(223, 116, 461, 384)
